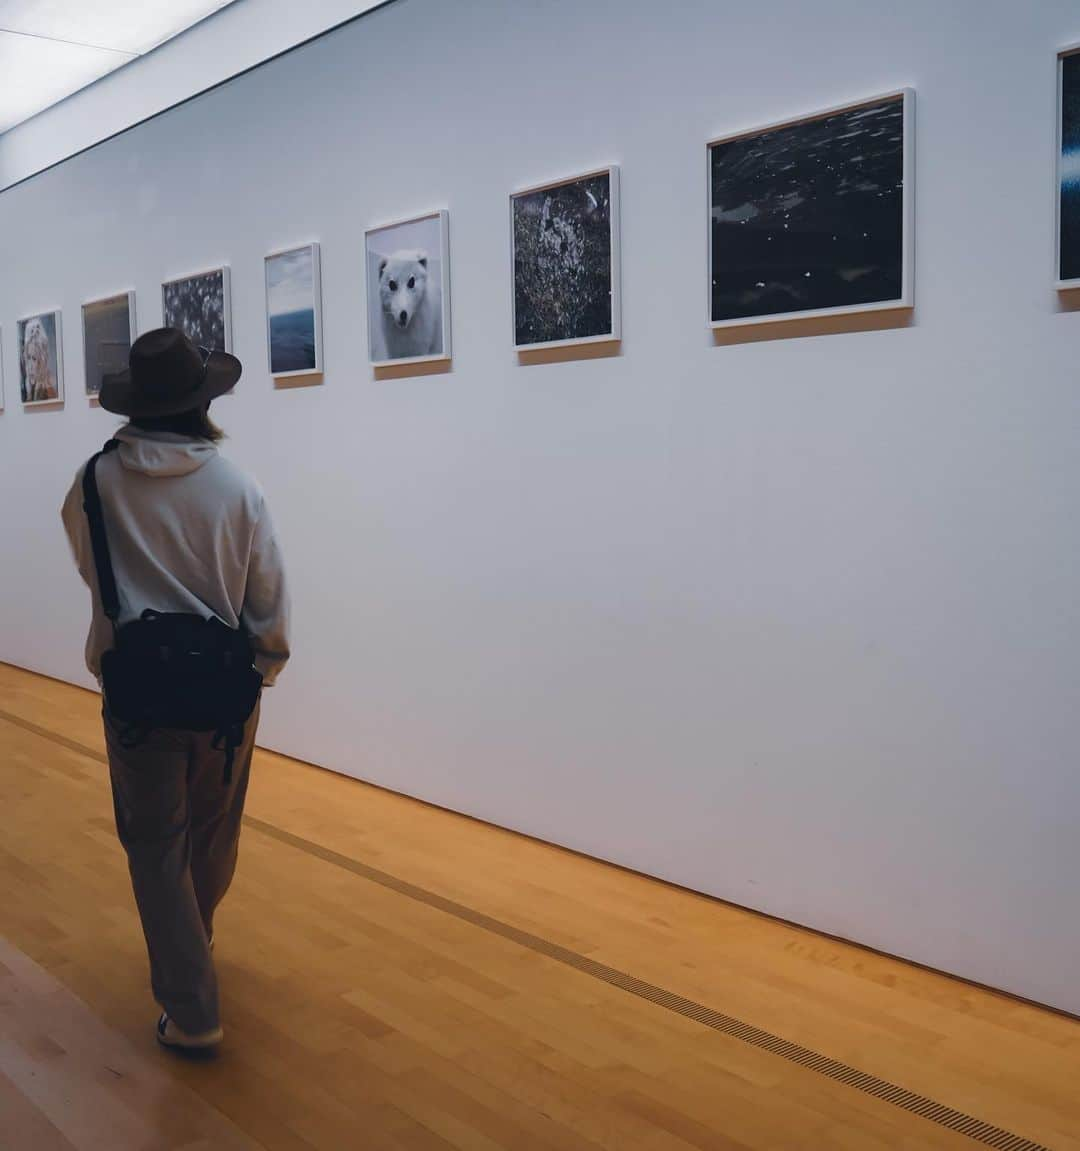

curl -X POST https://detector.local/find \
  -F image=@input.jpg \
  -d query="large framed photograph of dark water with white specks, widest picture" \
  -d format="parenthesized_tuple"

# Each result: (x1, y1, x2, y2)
(707, 89, 915, 328)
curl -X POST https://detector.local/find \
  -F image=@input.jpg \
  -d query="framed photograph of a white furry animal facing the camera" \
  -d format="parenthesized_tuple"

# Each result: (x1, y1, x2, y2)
(364, 209, 450, 367)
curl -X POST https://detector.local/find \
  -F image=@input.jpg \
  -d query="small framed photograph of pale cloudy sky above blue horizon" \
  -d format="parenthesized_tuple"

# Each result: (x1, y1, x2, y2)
(265, 244, 322, 380)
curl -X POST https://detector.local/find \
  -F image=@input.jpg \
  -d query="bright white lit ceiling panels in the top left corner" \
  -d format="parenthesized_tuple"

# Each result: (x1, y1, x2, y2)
(0, 0, 233, 132)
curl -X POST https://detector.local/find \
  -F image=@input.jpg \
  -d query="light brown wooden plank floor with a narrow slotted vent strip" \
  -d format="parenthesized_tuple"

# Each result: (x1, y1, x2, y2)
(0, 665, 1080, 1151)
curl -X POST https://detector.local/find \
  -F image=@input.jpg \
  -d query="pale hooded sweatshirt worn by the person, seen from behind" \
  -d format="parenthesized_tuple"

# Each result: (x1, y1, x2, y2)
(61, 426, 289, 686)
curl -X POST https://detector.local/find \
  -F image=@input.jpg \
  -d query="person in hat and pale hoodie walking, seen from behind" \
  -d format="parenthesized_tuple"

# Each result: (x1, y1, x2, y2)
(61, 328, 289, 1049)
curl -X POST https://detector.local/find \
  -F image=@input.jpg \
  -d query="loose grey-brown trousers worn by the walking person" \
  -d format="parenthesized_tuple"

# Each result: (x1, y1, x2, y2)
(105, 707, 259, 1034)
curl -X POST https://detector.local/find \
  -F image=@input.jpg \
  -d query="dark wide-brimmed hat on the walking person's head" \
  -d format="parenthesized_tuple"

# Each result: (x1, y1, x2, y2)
(98, 328, 243, 418)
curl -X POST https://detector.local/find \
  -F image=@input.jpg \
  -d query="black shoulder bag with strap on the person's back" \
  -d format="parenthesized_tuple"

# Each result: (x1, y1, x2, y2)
(83, 440, 263, 784)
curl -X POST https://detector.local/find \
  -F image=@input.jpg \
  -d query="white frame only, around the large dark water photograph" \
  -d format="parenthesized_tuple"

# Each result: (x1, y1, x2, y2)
(705, 87, 915, 330)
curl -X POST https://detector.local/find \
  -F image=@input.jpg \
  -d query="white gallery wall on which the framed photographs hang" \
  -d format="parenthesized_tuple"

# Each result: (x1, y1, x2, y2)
(0, 0, 1080, 1012)
